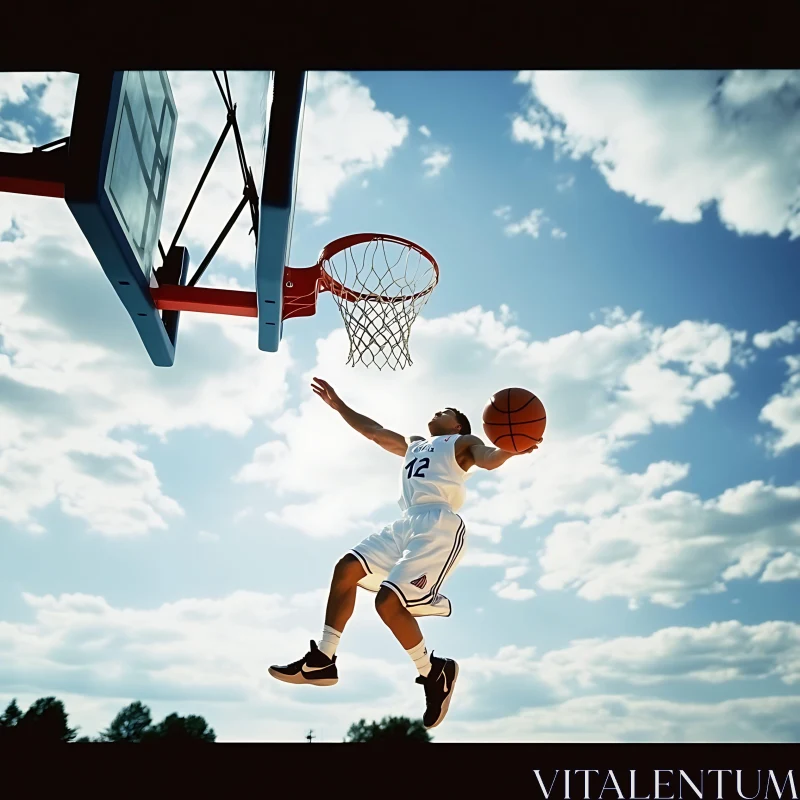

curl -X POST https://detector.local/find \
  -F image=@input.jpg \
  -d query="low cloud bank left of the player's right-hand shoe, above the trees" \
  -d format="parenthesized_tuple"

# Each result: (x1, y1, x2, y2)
(0, 591, 422, 741)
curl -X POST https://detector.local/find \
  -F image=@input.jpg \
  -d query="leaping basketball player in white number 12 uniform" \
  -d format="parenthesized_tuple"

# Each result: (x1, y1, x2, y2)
(269, 378, 541, 728)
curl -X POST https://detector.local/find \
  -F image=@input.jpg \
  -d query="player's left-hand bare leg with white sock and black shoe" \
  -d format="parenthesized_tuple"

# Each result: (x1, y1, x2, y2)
(269, 554, 366, 686)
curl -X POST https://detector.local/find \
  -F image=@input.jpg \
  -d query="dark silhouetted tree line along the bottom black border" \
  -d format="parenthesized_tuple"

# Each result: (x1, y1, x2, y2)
(0, 697, 431, 746)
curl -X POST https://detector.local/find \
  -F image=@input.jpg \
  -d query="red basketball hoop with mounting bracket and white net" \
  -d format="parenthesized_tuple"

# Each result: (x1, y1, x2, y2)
(283, 233, 439, 369)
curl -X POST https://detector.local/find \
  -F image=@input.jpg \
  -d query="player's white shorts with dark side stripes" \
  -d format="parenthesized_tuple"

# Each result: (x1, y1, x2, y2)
(350, 504, 466, 617)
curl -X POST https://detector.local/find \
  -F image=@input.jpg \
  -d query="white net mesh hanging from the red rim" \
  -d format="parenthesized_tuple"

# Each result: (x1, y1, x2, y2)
(322, 237, 439, 369)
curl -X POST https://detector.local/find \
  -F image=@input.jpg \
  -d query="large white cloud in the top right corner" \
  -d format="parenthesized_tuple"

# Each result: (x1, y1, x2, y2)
(512, 70, 800, 238)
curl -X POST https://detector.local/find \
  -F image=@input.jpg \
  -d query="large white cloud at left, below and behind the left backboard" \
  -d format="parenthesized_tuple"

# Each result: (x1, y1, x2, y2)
(0, 196, 291, 535)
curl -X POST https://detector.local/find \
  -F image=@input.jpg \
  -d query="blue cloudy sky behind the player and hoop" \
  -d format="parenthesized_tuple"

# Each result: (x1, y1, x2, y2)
(0, 70, 800, 742)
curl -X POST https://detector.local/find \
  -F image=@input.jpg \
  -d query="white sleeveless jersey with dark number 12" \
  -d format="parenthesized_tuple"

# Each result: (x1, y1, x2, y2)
(399, 433, 467, 511)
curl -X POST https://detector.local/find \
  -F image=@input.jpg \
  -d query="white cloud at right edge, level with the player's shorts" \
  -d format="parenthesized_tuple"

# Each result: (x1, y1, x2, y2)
(539, 481, 800, 608)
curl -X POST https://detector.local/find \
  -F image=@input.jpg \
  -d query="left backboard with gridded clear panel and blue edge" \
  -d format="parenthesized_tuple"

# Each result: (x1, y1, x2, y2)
(64, 71, 180, 366)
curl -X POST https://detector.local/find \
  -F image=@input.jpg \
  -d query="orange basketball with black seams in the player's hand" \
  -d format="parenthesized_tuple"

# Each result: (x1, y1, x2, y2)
(483, 388, 547, 453)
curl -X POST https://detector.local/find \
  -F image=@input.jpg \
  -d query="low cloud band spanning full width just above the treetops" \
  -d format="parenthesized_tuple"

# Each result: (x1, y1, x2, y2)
(0, 591, 800, 741)
